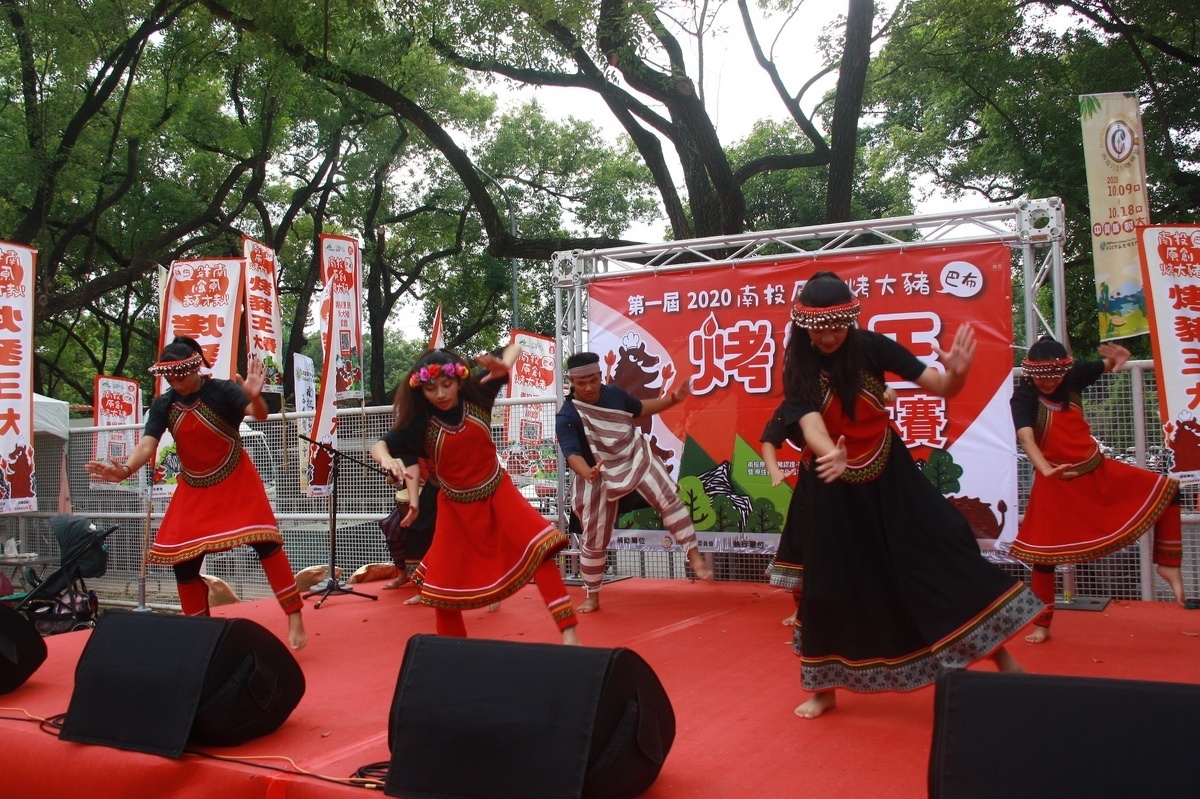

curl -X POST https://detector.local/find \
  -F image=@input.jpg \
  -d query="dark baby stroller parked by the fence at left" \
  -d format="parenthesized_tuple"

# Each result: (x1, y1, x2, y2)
(16, 513, 116, 636)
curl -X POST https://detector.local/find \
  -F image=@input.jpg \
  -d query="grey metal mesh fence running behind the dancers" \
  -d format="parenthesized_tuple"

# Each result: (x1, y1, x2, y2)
(0, 361, 1200, 606)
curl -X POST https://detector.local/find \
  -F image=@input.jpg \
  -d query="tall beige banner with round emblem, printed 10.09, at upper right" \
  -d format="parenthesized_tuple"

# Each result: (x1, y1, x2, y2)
(1079, 92, 1150, 341)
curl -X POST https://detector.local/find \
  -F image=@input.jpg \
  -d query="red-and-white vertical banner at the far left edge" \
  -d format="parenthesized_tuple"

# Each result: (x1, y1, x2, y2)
(0, 241, 37, 513)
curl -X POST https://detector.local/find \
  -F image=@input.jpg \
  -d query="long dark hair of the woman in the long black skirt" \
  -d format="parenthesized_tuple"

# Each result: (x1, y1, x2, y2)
(784, 271, 863, 419)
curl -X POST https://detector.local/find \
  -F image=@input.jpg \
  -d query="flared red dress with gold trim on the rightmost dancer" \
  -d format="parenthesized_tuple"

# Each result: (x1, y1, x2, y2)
(1009, 362, 1178, 564)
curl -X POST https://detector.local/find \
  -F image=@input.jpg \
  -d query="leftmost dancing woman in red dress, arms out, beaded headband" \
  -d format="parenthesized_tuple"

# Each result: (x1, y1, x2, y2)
(84, 336, 307, 649)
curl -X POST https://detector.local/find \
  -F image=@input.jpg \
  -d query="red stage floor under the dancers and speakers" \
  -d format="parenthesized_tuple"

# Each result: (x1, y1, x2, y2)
(0, 579, 1200, 799)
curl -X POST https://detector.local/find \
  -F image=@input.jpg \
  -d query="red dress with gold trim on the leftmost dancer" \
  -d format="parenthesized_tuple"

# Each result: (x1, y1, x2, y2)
(146, 378, 283, 565)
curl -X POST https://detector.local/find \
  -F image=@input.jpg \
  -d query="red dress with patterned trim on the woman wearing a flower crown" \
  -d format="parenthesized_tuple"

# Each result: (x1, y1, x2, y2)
(398, 402, 566, 611)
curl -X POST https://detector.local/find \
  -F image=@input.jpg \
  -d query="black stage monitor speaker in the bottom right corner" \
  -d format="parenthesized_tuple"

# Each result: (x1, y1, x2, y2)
(929, 671, 1200, 799)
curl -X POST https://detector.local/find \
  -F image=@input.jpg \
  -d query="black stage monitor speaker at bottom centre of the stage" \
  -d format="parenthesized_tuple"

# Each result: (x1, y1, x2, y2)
(384, 635, 674, 799)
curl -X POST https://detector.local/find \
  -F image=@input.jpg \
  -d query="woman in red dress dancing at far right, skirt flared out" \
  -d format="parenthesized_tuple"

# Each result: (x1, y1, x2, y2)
(1010, 336, 1184, 643)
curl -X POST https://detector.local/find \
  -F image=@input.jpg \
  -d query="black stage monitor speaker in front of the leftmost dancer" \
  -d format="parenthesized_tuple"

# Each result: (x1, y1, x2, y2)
(60, 611, 305, 757)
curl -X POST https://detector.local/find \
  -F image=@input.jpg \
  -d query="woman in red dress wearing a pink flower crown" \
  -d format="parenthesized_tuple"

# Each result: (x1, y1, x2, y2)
(371, 346, 580, 645)
